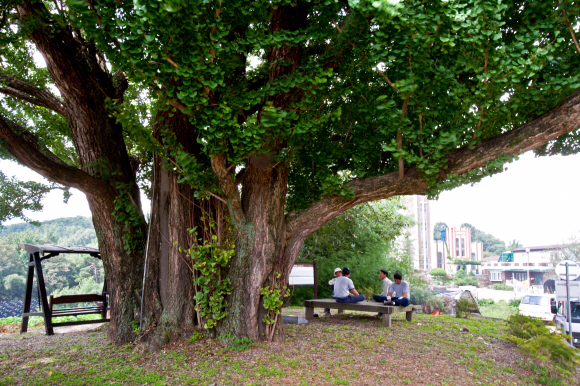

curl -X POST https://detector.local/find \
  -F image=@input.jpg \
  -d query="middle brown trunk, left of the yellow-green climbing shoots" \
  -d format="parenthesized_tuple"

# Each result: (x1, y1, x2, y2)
(140, 156, 199, 345)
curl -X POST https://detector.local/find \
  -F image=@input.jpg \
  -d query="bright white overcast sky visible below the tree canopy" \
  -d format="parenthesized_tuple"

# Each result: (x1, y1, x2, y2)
(0, 153, 580, 246)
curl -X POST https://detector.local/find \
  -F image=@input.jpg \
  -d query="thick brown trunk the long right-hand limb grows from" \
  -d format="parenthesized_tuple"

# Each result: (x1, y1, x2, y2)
(212, 154, 288, 340)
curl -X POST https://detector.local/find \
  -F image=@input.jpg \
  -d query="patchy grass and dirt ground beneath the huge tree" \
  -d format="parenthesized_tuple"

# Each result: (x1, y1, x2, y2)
(0, 309, 580, 386)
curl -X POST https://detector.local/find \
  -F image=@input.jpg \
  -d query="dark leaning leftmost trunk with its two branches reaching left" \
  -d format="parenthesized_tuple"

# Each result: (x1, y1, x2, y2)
(0, 1, 146, 344)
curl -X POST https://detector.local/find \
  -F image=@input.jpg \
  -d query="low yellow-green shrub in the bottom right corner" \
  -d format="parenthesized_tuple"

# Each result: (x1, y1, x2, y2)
(506, 315, 580, 379)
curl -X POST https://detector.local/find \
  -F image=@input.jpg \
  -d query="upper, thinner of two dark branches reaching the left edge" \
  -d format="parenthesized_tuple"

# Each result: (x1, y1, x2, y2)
(0, 74, 66, 117)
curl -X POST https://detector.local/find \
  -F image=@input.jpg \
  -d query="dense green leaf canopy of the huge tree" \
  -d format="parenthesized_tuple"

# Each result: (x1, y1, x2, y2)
(52, 0, 580, 211)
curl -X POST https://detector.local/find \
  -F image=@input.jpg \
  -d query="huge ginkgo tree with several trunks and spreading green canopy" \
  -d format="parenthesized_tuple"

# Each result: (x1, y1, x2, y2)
(0, 0, 580, 341)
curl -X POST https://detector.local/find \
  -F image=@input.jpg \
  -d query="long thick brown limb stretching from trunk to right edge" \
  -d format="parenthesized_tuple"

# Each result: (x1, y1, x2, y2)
(286, 90, 580, 244)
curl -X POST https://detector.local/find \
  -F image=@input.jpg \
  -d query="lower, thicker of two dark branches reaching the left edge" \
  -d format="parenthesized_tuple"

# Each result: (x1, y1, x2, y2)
(0, 116, 113, 194)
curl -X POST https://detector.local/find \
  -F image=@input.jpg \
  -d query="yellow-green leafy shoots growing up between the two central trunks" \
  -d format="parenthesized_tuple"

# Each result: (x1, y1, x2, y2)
(180, 213, 235, 330)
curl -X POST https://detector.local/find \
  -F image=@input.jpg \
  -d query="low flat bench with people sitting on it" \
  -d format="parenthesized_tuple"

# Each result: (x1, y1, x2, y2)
(304, 299, 419, 327)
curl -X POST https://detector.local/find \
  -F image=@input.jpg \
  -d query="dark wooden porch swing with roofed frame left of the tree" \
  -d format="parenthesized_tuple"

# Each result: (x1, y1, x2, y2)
(18, 244, 109, 335)
